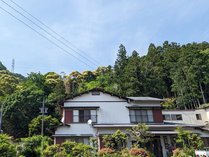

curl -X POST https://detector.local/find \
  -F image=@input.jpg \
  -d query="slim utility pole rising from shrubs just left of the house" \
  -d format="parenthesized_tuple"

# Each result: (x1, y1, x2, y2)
(39, 98, 48, 155)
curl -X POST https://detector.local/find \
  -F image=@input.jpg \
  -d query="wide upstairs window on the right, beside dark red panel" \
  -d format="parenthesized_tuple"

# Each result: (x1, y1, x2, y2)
(129, 110, 154, 123)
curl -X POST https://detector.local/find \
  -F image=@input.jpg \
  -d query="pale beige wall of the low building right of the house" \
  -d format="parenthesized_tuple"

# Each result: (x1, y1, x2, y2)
(162, 109, 208, 125)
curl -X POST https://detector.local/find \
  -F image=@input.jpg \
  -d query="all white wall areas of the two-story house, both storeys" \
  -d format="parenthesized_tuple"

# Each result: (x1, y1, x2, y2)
(55, 92, 160, 134)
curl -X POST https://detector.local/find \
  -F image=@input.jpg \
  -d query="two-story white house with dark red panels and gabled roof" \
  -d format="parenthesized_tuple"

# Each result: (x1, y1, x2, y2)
(54, 89, 209, 157)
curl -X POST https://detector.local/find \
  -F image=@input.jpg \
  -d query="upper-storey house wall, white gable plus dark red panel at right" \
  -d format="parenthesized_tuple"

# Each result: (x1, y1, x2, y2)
(64, 92, 163, 124)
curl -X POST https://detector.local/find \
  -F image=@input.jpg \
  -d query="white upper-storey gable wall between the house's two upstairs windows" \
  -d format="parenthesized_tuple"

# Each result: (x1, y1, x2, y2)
(64, 92, 130, 124)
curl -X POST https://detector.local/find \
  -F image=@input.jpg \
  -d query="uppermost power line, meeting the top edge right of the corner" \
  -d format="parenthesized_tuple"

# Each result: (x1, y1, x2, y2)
(8, 0, 99, 66)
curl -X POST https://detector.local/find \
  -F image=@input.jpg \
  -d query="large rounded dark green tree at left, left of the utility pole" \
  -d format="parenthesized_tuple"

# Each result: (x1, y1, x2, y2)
(3, 83, 44, 137)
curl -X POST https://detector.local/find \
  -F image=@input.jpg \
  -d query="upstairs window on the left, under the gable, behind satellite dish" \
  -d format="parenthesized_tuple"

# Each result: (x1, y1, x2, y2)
(73, 109, 97, 123)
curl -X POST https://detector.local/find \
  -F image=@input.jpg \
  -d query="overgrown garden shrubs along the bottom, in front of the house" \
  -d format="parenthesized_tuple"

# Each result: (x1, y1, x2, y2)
(0, 124, 203, 157)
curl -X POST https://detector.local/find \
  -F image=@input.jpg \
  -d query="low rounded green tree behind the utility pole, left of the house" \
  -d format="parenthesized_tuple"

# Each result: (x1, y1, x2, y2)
(29, 115, 60, 136)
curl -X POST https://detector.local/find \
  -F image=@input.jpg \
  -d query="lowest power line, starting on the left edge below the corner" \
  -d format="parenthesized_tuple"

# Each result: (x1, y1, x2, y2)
(0, 6, 94, 69)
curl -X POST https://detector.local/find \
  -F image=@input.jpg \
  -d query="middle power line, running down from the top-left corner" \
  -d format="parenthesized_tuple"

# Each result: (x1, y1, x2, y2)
(1, 0, 97, 66)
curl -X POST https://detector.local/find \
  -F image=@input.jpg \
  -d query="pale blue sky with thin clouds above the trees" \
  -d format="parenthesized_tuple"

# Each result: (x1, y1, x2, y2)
(0, 0, 209, 76)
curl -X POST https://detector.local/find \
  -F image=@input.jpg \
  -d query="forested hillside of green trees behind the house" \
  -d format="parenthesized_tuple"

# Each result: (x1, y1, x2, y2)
(0, 41, 209, 137)
